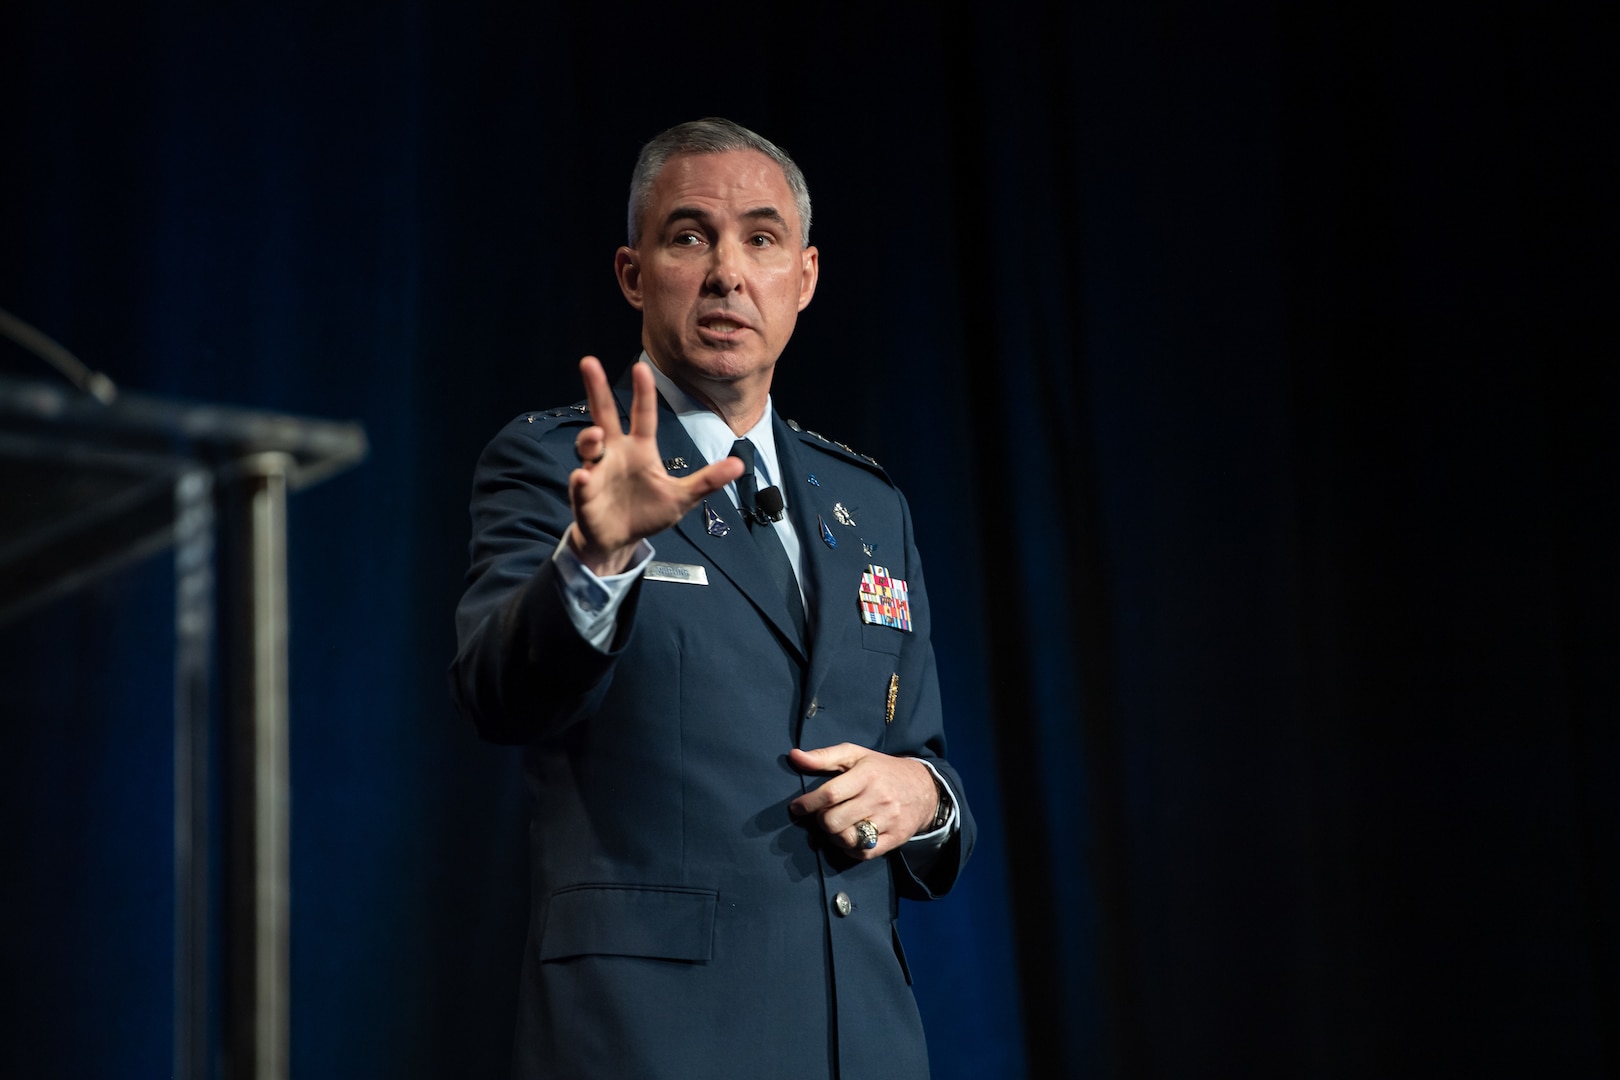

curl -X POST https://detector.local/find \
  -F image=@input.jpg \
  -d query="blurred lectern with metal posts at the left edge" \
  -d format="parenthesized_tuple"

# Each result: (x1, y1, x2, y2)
(0, 376, 366, 1080)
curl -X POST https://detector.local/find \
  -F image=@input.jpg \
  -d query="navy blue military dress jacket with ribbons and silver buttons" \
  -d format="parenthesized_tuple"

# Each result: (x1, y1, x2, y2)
(452, 365, 975, 1080)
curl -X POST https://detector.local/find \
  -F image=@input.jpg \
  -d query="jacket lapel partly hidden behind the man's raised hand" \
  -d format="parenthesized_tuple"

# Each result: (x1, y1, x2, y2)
(614, 369, 810, 664)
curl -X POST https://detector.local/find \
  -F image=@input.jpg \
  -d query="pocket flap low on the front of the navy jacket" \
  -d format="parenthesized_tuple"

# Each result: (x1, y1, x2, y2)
(539, 886, 718, 960)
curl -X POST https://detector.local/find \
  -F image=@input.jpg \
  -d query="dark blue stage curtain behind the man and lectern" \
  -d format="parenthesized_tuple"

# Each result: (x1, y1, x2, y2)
(0, 0, 1620, 1078)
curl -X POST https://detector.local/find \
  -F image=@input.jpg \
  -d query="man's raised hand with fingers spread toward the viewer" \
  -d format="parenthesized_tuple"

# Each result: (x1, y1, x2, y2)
(569, 356, 742, 576)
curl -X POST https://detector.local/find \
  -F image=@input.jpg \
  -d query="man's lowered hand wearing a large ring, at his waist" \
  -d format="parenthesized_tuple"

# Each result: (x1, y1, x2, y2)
(787, 743, 940, 858)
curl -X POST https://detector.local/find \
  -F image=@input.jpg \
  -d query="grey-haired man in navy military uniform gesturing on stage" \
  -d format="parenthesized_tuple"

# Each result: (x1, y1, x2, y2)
(452, 120, 975, 1080)
